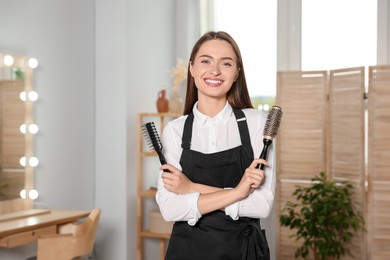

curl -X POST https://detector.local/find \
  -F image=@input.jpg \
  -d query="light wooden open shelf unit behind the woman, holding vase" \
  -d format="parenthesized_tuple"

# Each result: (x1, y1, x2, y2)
(137, 113, 179, 260)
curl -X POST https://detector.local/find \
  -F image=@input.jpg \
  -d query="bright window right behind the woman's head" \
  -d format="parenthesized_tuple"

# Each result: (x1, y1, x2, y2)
(206, 0, 277, 108)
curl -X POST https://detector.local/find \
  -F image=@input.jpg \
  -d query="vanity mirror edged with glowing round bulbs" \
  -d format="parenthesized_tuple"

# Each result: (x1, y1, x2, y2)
(0, 53, 38, 214)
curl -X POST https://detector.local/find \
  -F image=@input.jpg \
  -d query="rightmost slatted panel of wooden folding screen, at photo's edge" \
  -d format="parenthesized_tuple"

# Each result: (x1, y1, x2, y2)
(367, 66, 390, 259)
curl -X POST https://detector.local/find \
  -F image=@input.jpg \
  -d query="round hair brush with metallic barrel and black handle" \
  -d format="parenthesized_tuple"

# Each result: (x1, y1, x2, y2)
(257, 106, 283, 170)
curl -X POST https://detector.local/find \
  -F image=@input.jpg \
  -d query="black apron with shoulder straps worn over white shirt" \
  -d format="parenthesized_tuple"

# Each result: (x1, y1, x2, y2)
(165, 109, 269, 260)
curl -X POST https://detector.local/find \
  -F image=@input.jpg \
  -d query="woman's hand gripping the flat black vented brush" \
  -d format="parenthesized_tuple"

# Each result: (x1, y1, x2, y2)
(160, 164, 193, 194)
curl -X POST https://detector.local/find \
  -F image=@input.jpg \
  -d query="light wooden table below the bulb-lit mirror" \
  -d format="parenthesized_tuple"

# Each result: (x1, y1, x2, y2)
(0, 209, 90, 248)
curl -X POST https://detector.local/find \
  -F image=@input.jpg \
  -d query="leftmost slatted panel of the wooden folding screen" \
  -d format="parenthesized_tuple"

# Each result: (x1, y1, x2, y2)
(275, 71, 327, 259)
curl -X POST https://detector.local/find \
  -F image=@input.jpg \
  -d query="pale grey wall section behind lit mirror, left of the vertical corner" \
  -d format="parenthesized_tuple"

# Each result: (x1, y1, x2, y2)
(0, 0, 95, 260)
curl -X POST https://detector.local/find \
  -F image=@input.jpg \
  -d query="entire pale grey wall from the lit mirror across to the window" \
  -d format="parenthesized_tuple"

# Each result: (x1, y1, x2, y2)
(0, 0, 180, 260)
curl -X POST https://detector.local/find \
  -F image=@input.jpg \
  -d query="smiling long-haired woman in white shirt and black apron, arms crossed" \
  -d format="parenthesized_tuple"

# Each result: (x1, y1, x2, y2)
(156, 32, 275, 260)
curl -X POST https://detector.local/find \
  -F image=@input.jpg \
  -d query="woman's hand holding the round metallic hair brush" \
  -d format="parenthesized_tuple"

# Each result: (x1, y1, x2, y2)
(235, 159, 268, 199)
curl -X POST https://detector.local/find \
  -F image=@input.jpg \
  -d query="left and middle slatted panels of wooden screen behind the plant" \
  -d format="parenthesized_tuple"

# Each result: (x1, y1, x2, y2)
(275, 67, 367, 259)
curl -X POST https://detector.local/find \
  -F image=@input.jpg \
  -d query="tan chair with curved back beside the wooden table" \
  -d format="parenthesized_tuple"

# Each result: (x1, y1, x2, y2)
(37, 208, 101, 260)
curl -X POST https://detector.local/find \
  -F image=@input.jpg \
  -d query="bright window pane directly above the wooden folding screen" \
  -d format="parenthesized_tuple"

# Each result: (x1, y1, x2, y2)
(302, 0, 377, 70)
